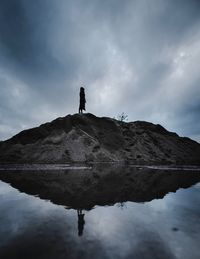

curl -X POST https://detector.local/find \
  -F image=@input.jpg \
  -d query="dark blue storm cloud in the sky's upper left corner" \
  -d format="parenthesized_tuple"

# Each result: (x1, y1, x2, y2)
(0, 0, 73, 80)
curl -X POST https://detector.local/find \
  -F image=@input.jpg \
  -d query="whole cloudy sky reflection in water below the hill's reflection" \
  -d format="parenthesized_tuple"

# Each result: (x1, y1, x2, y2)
(0, 182, 200, 259)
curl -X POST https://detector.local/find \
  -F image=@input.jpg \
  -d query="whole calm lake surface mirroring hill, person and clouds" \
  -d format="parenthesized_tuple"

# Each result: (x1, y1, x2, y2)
(0, 165, 200, 259)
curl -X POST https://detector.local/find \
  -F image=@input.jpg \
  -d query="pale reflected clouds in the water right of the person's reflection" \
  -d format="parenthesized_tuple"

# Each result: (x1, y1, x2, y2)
(87, 188, 199, 259)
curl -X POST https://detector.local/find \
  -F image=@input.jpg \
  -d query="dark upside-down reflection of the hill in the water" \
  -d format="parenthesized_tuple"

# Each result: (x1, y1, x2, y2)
(0, 165, 200, 210)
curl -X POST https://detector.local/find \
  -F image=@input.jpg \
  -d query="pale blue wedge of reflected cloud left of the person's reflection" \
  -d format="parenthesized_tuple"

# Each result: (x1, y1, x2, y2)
(0, 182, 69, 247)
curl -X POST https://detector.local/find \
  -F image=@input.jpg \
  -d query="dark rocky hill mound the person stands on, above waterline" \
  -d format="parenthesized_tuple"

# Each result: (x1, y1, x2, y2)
(0, 113, 200, 164)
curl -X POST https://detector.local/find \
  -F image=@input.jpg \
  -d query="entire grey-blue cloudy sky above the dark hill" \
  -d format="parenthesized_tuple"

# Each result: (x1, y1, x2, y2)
(0, 0, 200, 141)
